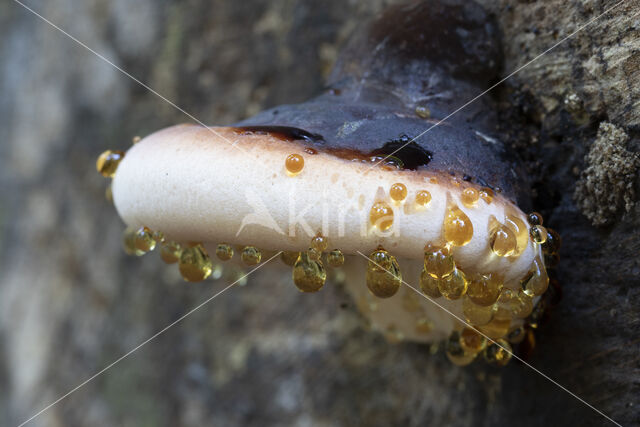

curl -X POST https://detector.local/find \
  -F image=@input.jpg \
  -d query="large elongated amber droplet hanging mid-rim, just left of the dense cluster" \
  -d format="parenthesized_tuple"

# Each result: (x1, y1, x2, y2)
(367, 247, 402, 298)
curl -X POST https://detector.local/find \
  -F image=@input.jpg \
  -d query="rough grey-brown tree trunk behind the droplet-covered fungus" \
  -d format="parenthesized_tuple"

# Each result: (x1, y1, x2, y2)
(0, 0, 640, 426)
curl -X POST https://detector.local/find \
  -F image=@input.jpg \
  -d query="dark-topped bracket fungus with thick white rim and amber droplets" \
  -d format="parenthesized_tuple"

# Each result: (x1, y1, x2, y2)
(97, 1, 559, 365)
